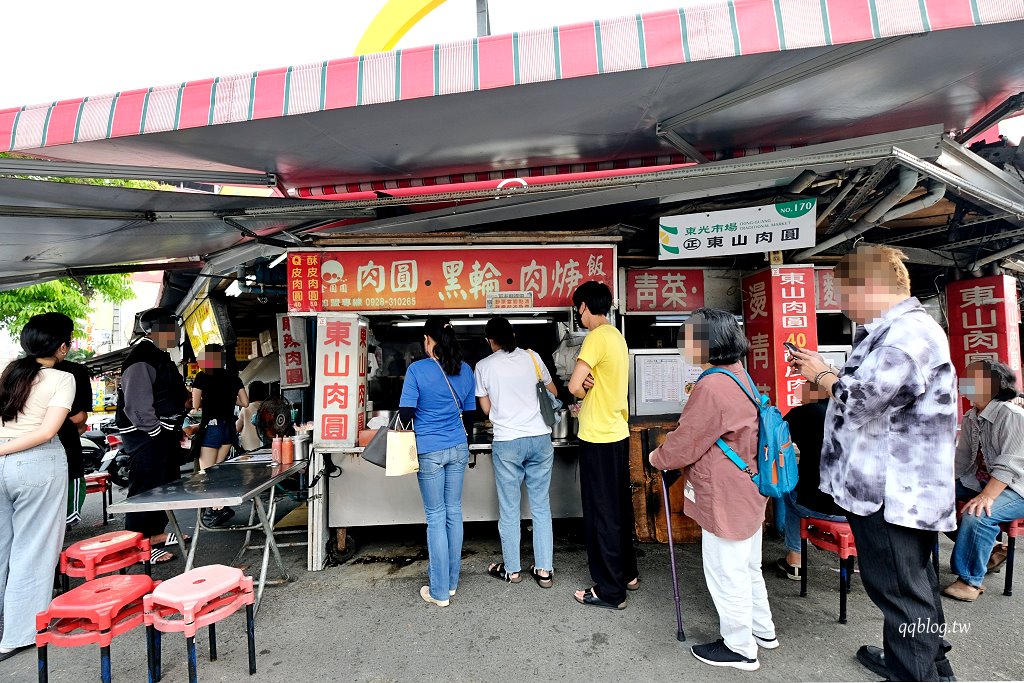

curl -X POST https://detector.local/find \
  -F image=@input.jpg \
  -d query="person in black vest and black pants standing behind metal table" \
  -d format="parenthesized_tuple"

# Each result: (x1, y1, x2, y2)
(115, 308, 188, 563)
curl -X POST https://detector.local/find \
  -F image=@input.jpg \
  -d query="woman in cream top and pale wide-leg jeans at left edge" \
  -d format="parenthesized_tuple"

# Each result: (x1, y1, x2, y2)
(0, 315, 75, 660)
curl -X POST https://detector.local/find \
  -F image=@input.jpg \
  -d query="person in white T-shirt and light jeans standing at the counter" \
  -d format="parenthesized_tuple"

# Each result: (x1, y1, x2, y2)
(476, 317, 556, 588)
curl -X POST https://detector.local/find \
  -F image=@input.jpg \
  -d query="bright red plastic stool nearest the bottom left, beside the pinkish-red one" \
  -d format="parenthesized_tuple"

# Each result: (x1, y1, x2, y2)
(36, 574, 156, 683)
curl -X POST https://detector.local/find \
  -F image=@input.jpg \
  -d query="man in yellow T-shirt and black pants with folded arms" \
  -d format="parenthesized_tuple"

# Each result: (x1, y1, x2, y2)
(569, 282, 640, 609)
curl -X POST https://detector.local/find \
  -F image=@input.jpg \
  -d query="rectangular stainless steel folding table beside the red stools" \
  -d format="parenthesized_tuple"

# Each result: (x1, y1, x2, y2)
(110, 452, 306, 609)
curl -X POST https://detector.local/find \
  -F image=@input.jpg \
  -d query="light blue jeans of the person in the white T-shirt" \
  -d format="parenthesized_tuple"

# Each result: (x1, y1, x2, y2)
(492, 434, 555, 573)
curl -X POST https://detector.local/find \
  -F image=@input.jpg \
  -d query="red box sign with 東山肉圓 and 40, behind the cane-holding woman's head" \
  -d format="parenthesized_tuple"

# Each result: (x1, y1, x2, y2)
(742, 266, 818, 415)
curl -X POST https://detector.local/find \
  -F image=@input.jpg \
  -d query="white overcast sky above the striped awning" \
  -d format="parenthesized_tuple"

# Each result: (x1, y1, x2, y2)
(0, 0, 693, 109)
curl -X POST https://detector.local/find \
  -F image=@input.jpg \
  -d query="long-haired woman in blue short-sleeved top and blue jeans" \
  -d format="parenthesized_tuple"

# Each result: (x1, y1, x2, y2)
(398, 315, 476, 607)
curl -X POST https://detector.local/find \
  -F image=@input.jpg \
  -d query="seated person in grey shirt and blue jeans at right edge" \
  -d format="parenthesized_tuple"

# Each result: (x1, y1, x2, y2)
(942, 360, 1024, 602)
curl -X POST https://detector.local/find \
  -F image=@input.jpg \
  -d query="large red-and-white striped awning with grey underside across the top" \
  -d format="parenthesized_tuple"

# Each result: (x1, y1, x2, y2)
(0, 0, 1024, 196)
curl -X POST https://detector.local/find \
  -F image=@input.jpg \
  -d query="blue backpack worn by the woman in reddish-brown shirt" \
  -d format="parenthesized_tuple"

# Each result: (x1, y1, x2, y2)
(697, 368, 798, 498)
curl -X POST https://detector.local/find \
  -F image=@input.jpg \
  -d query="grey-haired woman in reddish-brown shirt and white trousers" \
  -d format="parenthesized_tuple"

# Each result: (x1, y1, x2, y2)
(650, 308, 778, 671)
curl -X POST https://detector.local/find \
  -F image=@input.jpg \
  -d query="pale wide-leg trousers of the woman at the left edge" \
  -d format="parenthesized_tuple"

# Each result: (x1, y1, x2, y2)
(0, 438, 68, 649)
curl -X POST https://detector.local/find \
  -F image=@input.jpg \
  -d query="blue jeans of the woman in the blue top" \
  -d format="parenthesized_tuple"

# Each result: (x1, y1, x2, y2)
(416, 443, 469, 600)
